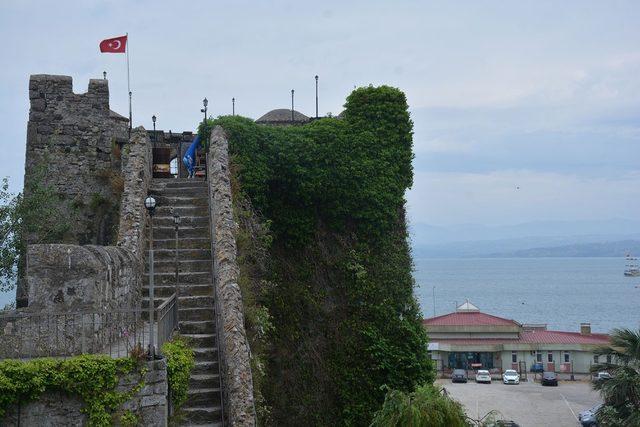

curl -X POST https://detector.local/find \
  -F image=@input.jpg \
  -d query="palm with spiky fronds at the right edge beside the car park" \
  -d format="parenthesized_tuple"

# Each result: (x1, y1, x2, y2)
(592, 329, 640, 426)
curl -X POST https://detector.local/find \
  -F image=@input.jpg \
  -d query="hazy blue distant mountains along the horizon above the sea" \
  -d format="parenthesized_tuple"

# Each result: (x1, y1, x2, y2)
(410, 219, 640, 258)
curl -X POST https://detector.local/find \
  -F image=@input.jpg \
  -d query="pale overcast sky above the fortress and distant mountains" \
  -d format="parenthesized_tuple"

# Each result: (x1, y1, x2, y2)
(0, 0, 640, 231)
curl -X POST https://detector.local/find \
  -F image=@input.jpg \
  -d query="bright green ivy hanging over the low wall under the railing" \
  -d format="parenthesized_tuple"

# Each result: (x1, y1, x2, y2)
(0, 355, 144, 426)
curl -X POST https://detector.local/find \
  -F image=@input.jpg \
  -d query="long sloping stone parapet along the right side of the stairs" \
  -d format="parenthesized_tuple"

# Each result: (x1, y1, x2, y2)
(207, 126, 256, 426)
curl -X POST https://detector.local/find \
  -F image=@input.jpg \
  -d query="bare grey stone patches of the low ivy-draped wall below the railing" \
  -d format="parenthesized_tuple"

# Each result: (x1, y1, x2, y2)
(0, 360, 168, 427)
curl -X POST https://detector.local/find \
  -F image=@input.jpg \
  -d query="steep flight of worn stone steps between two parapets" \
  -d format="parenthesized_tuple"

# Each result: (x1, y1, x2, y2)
(144, 179, 222, 426)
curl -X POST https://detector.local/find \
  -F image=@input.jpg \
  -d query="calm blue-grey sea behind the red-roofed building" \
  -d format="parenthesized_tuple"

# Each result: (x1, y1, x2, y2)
(414, 257, 640, 333)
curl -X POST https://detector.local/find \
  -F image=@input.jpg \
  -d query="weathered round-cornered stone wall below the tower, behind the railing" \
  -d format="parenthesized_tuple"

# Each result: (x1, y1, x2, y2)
(0, 244, 143, 358)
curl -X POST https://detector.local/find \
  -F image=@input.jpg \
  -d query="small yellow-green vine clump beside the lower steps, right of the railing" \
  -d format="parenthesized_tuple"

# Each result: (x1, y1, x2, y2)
(162, 336, 195, 411)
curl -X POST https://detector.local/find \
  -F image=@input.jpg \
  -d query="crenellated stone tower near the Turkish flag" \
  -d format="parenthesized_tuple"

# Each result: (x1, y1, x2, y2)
(16, 74, 129, 307)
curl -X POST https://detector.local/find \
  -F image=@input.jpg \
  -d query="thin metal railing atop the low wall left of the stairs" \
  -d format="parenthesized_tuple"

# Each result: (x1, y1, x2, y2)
(0, 294, 177, 359)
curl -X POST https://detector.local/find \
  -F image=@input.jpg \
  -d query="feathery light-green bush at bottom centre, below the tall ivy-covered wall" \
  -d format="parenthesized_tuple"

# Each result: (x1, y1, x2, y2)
(371, 384, 469, 427)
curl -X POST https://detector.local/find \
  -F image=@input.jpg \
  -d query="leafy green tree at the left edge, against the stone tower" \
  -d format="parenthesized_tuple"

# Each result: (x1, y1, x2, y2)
(0, 161, 73, 292)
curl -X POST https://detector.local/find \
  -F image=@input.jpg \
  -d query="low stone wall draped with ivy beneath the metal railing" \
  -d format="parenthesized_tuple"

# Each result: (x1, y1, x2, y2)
(0, 355, 168, 426)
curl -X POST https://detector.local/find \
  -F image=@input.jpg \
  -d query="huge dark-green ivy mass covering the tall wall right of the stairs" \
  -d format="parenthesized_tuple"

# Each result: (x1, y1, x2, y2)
(206, 86, 434, 425)
